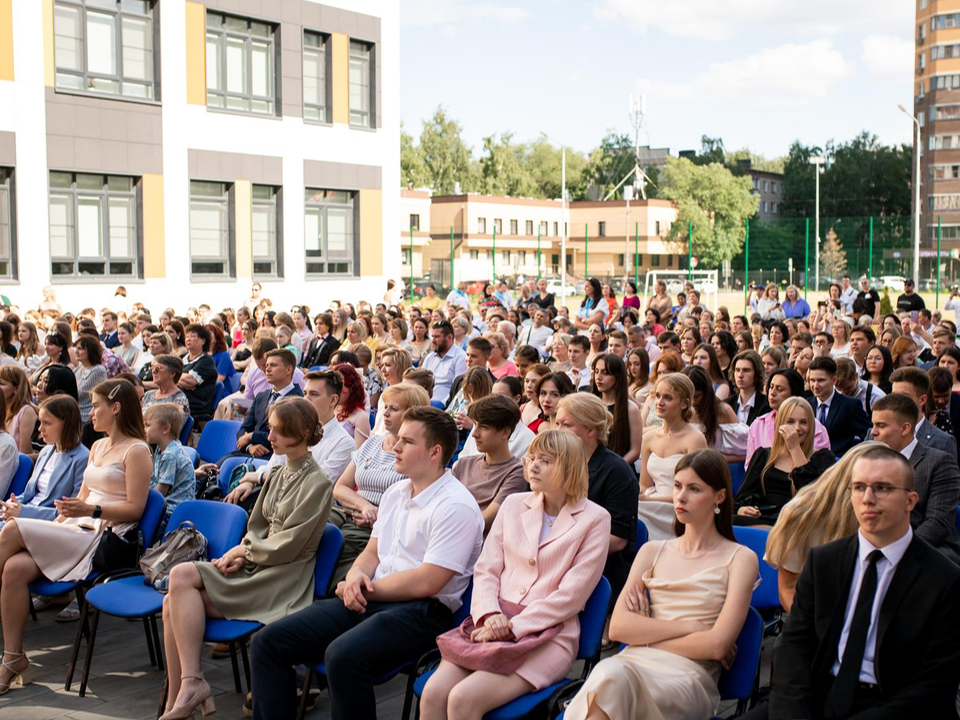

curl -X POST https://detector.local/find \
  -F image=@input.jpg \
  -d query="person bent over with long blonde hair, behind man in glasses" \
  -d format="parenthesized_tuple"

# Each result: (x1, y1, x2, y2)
(763, 440, 884, 613)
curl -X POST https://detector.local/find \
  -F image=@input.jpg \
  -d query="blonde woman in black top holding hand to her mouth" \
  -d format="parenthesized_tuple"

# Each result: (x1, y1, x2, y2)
(734, 397, 835, 526)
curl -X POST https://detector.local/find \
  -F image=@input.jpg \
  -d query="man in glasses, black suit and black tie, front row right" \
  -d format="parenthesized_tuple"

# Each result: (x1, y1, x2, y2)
(744, 448, 960, 720)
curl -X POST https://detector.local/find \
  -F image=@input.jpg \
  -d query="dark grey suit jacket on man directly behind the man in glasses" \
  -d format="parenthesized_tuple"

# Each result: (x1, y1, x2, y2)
(910, 442, 960, 564)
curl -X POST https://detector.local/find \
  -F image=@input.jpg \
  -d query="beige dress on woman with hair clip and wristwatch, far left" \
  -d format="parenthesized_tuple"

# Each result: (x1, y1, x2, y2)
(17, 440, 150, 582)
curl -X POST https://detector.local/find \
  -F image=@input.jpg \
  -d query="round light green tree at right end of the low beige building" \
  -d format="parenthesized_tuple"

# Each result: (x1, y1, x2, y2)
(660, 157, 757, 268)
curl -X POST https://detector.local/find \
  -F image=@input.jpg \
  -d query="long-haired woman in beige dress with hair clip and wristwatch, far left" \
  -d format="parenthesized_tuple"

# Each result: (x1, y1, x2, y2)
(0, 380, 153, 695)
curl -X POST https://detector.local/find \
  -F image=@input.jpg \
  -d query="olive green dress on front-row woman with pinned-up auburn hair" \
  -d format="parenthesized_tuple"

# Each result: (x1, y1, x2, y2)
(197, 453, 333, 625)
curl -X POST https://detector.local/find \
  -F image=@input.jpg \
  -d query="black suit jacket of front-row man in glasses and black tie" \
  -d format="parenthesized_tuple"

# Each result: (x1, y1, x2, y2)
(769, 534, 960, 720)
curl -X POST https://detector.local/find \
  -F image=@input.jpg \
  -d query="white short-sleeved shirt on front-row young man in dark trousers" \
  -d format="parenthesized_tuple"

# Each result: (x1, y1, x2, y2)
(371, 470, 483, 612)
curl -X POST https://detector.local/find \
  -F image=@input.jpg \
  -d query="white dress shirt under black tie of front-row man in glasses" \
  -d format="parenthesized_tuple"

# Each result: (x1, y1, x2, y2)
(830, 526, 913, 685)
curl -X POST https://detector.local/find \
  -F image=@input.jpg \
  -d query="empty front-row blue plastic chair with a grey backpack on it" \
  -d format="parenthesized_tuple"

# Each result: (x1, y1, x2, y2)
(66, 500, 247, 697)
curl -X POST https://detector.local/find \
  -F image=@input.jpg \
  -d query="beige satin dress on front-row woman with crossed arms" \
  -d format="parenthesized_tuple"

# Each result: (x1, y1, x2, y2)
(564, 542, 742, 720)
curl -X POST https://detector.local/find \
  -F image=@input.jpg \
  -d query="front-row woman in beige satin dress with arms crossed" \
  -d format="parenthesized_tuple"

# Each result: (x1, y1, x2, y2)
(564, 449, 759, 720)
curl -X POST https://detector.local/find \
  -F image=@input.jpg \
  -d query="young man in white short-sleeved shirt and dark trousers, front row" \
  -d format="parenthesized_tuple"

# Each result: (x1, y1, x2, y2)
(251, 407, 483, 720)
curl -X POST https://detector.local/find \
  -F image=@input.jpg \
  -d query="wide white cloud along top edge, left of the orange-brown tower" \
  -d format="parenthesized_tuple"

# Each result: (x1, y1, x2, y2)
(594, 0, 913, 40)
